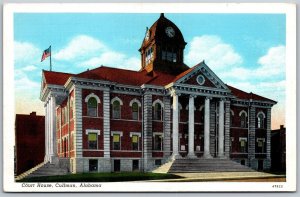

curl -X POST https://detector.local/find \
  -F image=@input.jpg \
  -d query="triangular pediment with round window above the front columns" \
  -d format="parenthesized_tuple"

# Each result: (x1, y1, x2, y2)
(175, 62, 229, 90)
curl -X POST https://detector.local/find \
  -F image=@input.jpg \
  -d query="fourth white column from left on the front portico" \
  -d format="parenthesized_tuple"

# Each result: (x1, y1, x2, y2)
(218, 99, 225, 158)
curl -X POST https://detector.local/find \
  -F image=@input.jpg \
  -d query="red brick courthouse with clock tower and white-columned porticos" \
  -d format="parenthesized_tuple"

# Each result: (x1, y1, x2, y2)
(41, 14, 276, 173)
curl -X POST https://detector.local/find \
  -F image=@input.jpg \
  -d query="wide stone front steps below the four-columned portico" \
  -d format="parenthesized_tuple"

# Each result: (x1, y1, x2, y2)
(168, 158, 255, 173)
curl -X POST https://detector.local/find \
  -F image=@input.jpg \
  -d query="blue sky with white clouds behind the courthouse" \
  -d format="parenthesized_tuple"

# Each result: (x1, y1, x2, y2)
(14, 13, 286, 127)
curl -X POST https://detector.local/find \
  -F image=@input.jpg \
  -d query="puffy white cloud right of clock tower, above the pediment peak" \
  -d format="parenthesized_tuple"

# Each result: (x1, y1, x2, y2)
(186, 35, 243, 70)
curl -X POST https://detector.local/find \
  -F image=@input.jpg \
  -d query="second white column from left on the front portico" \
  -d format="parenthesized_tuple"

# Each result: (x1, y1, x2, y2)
(187, 95, 196, 158)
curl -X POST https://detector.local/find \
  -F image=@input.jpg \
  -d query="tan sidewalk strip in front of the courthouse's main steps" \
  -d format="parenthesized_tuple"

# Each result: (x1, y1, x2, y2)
(151, 172, 285, 182)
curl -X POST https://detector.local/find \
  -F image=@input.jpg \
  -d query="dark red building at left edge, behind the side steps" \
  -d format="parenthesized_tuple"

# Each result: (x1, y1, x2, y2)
(15, 112, 45, 175)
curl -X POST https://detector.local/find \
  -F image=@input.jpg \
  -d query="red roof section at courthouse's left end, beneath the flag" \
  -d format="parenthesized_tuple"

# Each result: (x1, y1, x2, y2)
(43, 70, 73, 85)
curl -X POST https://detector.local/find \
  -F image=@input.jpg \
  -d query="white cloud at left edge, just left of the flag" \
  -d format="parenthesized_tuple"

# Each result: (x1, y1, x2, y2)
(14, 41, 42, 63)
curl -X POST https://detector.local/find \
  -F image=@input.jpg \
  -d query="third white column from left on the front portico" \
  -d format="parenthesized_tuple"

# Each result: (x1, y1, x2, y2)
(203, 97, 212, 158)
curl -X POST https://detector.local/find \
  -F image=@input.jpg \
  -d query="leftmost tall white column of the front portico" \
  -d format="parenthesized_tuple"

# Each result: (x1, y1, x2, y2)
(172, 92, 180, 158)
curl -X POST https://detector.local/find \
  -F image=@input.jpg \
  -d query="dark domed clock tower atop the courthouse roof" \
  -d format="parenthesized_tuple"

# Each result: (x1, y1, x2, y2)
(139, 14, 189, 75)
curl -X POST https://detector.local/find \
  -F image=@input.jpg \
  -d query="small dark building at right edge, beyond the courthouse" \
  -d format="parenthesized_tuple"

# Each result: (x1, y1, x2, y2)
(271, 125, 286, 172)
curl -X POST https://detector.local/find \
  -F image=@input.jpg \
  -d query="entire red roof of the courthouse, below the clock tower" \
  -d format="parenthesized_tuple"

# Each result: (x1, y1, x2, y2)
(43, 64, 276, 102)
